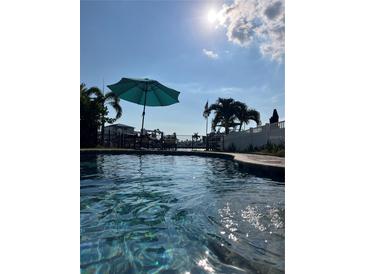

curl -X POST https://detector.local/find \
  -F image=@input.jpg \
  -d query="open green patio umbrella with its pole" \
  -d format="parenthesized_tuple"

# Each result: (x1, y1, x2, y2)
(107, 78, 180, 133)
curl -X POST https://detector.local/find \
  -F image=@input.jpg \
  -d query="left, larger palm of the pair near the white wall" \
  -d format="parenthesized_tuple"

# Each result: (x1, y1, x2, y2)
(204, 98, 236, 134)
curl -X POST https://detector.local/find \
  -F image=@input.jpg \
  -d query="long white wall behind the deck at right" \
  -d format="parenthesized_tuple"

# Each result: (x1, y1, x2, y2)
(224, 121, 285, 151)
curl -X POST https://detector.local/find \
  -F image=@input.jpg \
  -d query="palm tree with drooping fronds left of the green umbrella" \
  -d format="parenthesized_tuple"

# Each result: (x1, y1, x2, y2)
(86, 87, 122, 145)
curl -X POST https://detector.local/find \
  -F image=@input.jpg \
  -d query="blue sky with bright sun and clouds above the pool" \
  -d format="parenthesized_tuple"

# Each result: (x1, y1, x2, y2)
(80, 0, 285, 135)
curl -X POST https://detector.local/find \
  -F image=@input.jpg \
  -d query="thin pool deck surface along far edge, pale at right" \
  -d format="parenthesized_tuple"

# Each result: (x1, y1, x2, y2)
(80, 148, 285, 170)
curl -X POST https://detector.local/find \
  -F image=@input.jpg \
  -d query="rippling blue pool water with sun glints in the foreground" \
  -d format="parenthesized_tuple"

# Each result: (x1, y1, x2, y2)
(80, 154, 285, 273)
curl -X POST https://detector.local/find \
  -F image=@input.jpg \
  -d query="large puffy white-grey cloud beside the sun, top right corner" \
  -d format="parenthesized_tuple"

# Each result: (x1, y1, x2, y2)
(218, 0, 285, 62)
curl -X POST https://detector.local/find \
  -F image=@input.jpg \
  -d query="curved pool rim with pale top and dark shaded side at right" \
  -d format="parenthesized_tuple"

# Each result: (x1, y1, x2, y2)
(80, 148, 285, 182)
